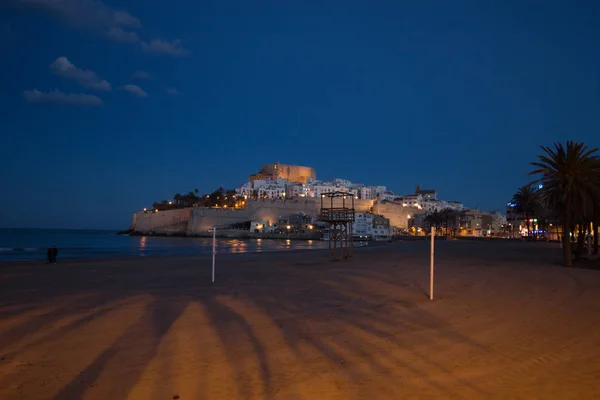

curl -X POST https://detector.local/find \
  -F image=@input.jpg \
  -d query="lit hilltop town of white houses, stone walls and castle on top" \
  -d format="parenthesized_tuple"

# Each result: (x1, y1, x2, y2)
(130, 163, 510, 240)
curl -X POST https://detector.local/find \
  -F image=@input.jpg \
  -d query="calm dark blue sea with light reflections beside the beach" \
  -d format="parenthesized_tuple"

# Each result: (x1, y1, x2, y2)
(0, 229, 327, 262)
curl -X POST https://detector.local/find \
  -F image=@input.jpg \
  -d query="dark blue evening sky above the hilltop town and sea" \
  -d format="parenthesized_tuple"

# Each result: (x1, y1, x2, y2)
(0, 0, 600, 229)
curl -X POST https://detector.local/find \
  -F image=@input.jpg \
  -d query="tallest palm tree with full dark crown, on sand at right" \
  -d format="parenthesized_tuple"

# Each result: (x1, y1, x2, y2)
(529, 141, 600, 266)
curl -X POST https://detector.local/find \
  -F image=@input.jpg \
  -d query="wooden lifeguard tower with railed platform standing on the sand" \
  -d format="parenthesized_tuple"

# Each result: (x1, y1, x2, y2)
(319, 192, 354, 261)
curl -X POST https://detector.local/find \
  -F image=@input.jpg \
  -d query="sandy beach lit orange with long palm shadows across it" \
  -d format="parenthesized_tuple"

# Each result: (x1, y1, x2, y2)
(0, 241, 600, 400)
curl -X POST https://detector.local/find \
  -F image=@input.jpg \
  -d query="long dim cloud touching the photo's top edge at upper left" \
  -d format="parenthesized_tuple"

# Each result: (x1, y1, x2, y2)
(15, 0, 142, 41)
